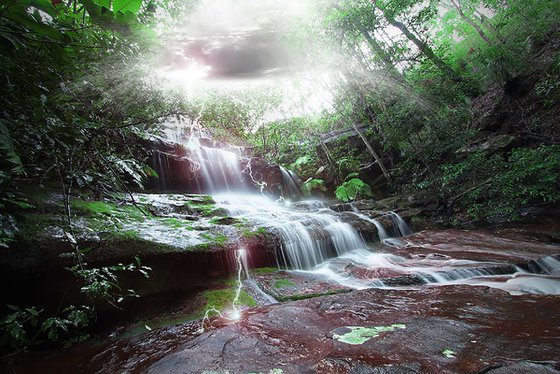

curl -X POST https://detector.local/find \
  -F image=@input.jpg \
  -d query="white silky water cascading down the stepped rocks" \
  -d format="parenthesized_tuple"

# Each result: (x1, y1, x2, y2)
(158, 130, 560, 302)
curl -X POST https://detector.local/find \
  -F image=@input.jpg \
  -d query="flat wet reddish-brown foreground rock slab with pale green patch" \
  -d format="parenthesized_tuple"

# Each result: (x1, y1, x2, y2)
(57, 286, 560, 374)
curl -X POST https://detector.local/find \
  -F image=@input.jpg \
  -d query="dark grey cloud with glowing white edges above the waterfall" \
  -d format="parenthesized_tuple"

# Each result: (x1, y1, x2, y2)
(158, 0, 306, 79)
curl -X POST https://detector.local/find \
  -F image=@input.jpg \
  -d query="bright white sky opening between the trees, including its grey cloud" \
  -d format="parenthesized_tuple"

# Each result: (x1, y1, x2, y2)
(150, 0, 333, 121)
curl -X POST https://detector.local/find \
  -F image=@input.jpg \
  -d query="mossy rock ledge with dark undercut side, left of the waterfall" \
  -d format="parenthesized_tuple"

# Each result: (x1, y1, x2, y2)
(0, 194, 279, 315)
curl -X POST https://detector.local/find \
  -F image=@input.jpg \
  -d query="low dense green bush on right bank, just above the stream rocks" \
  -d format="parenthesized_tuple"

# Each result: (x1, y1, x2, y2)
(434, 146, 560, 220)
